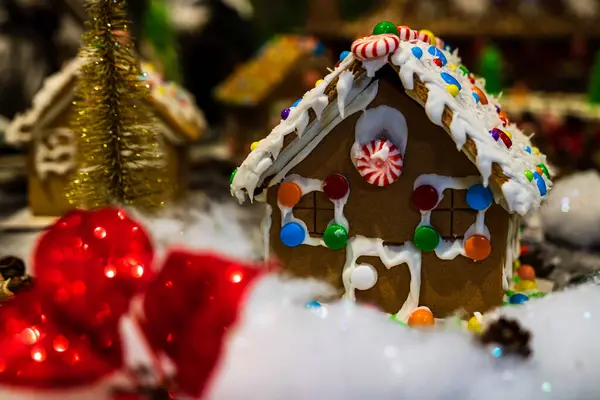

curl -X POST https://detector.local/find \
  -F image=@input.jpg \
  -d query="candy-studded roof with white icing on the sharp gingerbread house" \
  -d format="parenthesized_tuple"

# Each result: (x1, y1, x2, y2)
(231, 31, 552, 215)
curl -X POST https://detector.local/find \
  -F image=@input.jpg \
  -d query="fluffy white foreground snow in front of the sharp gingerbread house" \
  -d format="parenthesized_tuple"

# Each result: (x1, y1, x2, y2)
(208, 277, 600, 400)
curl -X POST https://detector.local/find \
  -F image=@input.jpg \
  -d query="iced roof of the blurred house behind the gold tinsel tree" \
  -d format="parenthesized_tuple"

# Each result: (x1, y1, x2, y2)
(6, 58, 206, 144)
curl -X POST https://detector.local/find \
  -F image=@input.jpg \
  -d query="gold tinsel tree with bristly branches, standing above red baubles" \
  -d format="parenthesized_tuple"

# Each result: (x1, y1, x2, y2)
(67, 0, 169, 211)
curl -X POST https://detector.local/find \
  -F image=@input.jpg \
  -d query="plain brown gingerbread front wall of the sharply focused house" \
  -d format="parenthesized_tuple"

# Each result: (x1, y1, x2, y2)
(268, 76, 509, 317)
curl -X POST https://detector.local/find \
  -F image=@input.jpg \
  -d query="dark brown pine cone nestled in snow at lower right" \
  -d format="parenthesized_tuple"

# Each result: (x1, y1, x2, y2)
(478, 317, 531, 358)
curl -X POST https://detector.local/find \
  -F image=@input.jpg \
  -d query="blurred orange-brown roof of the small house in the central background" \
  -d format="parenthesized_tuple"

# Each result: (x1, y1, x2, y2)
(216, 35, 321, 106)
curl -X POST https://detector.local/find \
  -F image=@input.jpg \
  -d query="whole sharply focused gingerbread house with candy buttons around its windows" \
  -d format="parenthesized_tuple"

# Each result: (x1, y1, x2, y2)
(231, 23, 552, 318)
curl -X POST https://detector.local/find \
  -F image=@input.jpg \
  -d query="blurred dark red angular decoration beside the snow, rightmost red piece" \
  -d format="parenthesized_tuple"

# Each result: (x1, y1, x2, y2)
(144, 251, 262, 396)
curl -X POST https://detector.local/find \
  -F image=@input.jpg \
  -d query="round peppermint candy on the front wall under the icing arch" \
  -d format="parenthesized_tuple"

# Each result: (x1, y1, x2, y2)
(355, 139, 404, 186)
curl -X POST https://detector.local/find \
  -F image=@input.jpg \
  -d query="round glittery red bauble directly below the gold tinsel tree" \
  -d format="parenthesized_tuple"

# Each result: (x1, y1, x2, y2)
(33, 208, 153, 330)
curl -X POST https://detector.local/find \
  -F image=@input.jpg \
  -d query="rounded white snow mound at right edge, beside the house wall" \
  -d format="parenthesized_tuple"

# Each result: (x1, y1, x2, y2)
(540, 171, 600, 248)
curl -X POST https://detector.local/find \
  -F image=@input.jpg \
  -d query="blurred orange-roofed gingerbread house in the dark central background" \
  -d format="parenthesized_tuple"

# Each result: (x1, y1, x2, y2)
(216, 35, 330, 159)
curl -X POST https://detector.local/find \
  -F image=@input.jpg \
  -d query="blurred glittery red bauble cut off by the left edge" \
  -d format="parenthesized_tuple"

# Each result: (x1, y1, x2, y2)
(0, 287, 122, 389)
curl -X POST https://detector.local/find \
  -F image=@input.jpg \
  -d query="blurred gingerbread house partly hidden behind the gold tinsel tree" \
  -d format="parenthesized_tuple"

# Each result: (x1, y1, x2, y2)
(6, 58, 205, 216)
